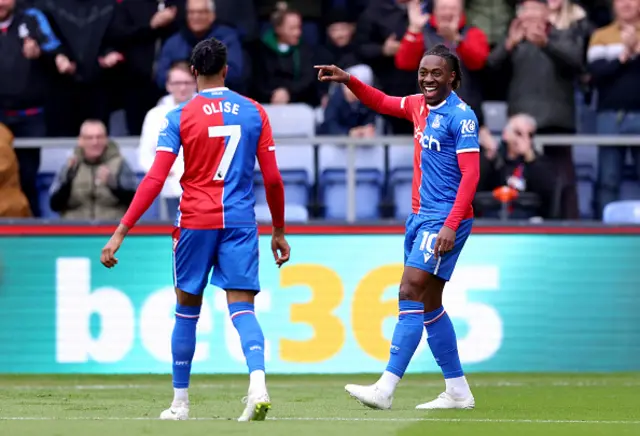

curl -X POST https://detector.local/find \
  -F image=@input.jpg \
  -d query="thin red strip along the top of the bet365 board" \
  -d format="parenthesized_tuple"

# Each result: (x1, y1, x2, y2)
(0, 223, 640, 236)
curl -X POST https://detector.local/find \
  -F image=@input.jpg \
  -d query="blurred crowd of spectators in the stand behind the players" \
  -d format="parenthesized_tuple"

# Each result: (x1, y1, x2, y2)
(0, 0, 640, 219)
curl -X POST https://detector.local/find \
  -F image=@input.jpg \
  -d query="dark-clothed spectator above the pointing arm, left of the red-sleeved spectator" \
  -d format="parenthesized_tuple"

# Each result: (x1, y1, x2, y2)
(354, 0, 419, 135)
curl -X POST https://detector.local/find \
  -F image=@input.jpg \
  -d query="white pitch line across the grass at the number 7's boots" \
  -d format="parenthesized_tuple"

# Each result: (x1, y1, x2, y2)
(0, 416, 640, 425)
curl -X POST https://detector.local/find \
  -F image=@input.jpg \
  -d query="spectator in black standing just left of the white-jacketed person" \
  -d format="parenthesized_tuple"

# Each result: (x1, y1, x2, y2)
(112, 0, 184, 135)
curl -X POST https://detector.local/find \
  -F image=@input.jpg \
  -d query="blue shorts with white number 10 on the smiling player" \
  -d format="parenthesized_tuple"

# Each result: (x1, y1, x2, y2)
(404, 214, 473, 281)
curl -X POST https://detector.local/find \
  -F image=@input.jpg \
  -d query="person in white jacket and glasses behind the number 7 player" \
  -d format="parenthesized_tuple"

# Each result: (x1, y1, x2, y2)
(138, 62, 196, 220)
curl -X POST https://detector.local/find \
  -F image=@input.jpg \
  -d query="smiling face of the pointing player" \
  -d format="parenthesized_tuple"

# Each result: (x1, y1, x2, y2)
(418, 55, 456, 106)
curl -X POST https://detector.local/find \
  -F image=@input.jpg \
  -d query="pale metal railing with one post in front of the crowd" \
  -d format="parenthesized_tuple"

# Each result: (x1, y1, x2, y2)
(14, 135, 640, 223)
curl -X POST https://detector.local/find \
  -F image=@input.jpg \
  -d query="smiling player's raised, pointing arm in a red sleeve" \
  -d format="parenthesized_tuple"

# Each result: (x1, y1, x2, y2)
(315, 65, 412, 121)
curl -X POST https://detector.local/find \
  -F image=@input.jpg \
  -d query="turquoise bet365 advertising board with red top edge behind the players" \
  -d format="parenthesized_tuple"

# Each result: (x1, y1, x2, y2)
(0, 223, 640, 374)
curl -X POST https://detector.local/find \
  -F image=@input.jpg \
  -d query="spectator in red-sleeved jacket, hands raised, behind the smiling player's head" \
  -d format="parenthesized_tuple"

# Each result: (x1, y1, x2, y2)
(395, 0, 489, 141)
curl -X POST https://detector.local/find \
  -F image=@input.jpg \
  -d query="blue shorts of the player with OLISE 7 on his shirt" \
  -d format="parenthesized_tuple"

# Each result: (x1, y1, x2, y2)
(173, 227, 260, 295)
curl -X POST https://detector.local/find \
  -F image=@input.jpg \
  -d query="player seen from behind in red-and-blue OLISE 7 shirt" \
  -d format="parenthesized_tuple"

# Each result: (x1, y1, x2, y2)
(101, 38, 290, 421)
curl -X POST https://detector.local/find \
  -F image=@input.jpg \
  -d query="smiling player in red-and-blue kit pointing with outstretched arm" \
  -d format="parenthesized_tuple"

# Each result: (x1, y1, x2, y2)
(316, 45, 480, 409)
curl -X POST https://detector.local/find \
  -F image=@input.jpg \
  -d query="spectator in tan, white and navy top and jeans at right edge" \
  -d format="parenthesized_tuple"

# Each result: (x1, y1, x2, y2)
(588, 0, 640, 217)
